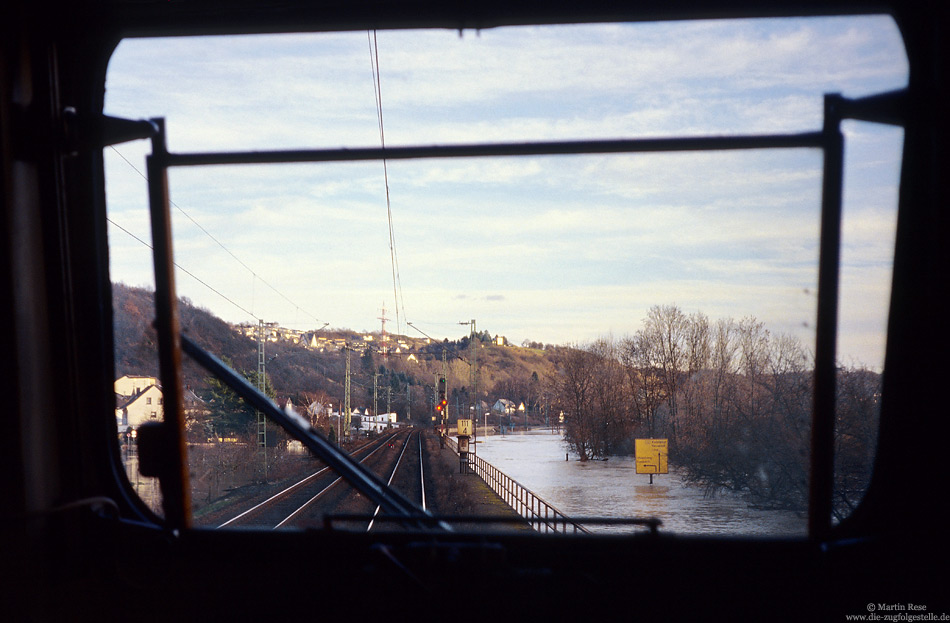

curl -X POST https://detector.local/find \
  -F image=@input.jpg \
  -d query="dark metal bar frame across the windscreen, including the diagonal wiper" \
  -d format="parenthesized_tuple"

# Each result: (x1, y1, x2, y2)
(128, 90, 906, 540)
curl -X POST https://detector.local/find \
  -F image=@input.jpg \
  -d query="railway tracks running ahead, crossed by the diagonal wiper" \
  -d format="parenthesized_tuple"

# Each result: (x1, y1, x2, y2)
(214, 429, 433, 530)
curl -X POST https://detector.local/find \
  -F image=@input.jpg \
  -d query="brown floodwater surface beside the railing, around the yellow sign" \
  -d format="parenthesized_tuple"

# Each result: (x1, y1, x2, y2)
(478, 429, 807, 537)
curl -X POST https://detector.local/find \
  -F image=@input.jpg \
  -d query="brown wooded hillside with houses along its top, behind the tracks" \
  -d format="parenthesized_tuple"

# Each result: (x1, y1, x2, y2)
(113, 284, 554, 419)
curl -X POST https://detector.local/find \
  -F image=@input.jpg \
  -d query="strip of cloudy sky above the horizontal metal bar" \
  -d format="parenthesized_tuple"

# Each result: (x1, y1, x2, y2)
(107, 18, 906, 148)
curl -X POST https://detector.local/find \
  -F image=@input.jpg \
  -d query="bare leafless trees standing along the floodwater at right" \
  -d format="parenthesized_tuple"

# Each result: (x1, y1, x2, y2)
(549, 305, 880, 518)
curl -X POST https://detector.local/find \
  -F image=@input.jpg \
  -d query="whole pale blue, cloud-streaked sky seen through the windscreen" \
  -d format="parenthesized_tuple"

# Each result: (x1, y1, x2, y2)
(105, 17, 908, 368)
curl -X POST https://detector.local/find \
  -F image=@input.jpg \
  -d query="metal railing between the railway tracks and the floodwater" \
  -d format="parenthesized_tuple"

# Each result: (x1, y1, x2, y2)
(447, 437, 590, 534)
